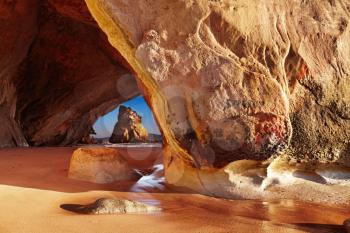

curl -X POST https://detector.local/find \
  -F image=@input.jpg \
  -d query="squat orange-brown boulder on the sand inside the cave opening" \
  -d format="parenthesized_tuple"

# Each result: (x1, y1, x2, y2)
(68, 147, 139, 184)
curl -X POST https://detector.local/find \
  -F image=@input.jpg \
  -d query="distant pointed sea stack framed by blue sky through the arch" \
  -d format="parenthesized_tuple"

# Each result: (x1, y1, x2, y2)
(109, 105, 148, 143)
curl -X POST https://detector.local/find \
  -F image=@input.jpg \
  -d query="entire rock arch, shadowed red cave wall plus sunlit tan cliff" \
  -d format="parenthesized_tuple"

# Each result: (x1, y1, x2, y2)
(0, 0, 350, 201)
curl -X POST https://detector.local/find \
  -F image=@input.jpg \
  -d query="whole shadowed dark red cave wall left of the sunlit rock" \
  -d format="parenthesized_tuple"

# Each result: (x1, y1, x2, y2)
(0, 1, 139, 147)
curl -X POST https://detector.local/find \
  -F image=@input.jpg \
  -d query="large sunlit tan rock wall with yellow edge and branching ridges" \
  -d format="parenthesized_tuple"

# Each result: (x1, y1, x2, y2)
(86, 0, 350, 196)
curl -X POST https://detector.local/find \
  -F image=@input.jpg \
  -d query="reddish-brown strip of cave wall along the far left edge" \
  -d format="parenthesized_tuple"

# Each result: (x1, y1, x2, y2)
(0, 0, 38, 146)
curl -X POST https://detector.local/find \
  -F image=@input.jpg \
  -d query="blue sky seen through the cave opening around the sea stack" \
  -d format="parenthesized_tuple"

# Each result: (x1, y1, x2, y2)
(93, 96, 160, 138)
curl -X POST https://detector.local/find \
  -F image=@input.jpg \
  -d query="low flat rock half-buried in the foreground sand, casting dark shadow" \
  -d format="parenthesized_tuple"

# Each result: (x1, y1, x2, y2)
(61, 198, 161, 215)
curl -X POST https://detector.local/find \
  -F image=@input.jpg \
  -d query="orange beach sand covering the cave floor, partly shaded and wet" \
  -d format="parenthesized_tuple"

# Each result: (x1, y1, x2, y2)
(0, 148, 350, 233)
